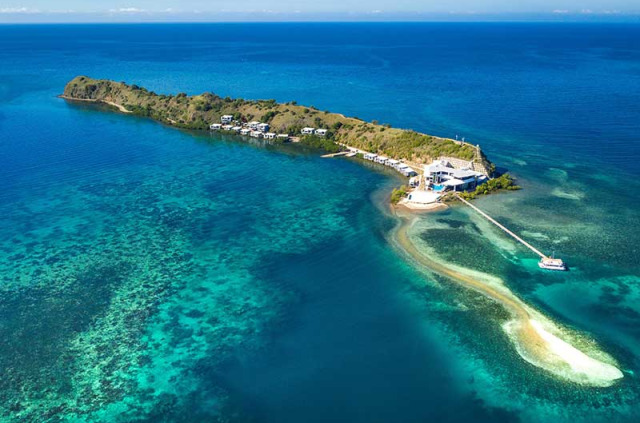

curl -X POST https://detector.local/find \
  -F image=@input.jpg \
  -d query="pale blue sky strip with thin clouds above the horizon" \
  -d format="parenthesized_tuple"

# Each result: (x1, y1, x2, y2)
(0, 0, 640, 22)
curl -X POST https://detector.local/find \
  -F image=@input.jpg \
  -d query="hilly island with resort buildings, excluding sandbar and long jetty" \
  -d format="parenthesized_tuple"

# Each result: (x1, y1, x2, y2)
(60, 76, 518, 210)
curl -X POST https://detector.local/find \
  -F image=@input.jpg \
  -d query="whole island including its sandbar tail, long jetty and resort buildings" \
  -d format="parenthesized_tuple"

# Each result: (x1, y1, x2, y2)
(61, 76, 623, 387)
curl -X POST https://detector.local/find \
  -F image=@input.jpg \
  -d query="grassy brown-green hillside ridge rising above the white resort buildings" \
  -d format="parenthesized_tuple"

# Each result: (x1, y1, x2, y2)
(61, 76, 493, 174)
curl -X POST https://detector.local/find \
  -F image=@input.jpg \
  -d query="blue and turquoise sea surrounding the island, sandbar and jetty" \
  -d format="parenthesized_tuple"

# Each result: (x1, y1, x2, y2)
(0, 23, 640, 423)
